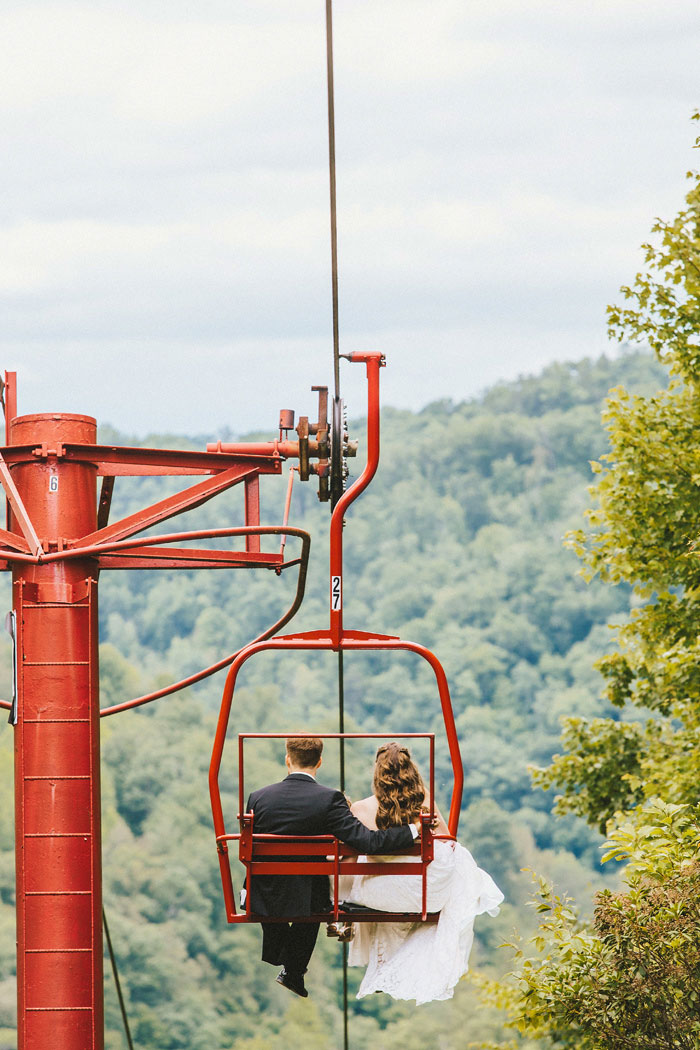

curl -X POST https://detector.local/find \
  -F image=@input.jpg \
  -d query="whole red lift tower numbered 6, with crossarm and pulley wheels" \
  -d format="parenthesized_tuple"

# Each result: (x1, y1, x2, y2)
(0, 373, 344, 1050)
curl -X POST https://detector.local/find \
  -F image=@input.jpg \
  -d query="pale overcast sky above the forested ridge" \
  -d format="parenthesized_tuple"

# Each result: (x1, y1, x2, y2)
(0, 0, 700, 435)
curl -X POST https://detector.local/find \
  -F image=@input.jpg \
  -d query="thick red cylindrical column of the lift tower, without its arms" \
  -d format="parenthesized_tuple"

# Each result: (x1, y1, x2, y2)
(10, 414, 104, 1050)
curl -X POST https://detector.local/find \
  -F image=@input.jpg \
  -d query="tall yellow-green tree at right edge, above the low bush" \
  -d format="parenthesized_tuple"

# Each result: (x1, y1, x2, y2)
(537, 114, 700, 823)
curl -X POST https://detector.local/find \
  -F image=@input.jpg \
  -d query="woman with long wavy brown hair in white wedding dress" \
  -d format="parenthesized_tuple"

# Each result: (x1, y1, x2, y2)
(340, 742, 503, 1004)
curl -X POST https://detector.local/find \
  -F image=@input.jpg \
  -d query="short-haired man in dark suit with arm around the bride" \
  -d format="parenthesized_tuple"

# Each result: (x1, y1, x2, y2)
(246, 736, 419, 999)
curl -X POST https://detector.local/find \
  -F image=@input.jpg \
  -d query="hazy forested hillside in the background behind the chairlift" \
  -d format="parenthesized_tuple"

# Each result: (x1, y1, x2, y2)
(0, 354, 665, 1050)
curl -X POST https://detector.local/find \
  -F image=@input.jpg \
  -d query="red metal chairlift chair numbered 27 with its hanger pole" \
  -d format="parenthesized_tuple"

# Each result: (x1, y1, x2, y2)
(209, 352, 464, 923)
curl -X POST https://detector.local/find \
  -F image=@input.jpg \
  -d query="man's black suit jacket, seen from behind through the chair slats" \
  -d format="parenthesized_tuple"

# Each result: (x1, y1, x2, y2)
(246, 773, 413, 917)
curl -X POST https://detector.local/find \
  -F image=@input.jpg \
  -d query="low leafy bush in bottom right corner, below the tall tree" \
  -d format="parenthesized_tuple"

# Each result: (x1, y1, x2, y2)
(483, 802, 700, 1050)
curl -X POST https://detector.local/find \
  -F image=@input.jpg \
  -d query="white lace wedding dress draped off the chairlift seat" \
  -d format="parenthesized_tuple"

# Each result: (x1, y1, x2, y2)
(341, 839, 503, 1004)
